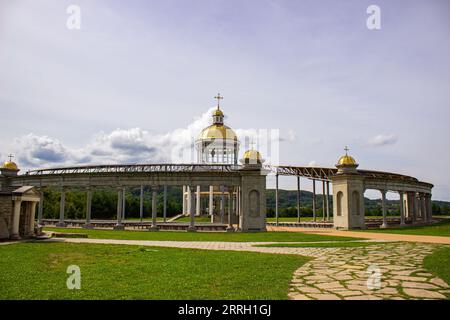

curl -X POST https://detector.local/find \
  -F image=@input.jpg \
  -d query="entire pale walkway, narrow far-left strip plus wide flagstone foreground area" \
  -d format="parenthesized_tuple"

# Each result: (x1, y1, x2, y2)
(47, 238, 450, 300)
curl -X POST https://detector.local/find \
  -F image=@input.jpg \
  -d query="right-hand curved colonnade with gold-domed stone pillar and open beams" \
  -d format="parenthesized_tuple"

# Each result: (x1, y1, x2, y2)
(267, 152, 433, 229)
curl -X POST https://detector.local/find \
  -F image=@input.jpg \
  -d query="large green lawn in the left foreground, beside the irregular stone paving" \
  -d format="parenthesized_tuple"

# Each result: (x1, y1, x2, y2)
(0, 242, 309, 300)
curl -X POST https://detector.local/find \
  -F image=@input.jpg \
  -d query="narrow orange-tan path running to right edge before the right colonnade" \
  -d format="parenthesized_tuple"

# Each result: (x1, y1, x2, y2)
(267, 227, 450, 244)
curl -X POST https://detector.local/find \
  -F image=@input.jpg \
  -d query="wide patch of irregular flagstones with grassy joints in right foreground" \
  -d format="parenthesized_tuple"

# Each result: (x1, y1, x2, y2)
(289, 242, 450, 300)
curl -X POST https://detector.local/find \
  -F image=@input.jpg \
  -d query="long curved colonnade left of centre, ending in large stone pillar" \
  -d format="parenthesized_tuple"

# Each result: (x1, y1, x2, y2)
(2, 164, 266, 236)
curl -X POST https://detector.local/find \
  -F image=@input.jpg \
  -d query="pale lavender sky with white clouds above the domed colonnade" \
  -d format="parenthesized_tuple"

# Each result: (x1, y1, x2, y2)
(0, 0, 450, 200)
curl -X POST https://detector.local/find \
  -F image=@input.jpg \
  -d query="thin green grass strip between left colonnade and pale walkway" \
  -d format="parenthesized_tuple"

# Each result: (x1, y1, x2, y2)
(44, 228, 361, 242)
